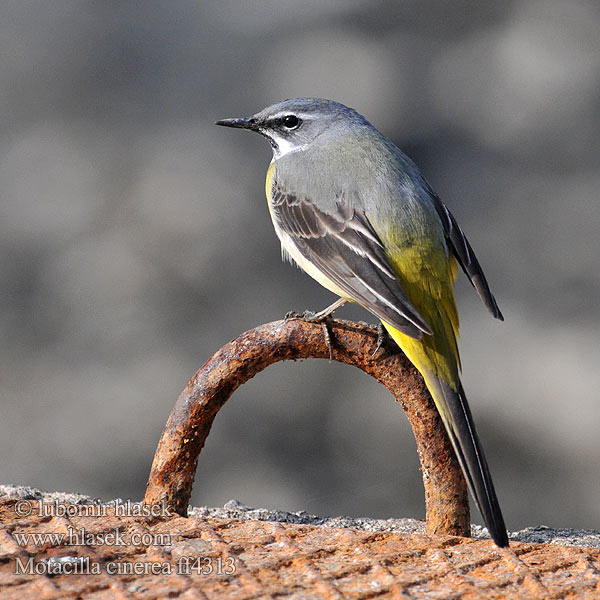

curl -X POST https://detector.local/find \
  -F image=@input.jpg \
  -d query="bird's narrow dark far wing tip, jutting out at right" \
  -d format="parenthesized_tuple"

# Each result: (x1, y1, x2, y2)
(431, 193, 504, 321)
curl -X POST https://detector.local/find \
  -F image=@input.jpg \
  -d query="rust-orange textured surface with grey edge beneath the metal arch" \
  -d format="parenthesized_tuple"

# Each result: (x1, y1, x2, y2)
(0, 486, 600, 600)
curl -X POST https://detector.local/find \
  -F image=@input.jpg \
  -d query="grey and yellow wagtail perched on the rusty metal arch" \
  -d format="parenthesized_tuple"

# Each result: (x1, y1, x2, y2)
(216, 98, 508, 547)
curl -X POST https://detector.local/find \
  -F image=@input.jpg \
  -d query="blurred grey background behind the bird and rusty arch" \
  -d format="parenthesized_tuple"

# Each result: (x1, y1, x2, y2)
(0, 0, 600, 529)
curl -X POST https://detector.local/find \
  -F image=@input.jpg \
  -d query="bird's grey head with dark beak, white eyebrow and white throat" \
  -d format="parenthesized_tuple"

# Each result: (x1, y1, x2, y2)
(216, 98, 372, 159)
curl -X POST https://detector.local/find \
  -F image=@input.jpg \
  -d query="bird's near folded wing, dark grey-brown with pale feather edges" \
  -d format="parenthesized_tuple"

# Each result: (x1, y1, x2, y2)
(271, 185, 432, 339)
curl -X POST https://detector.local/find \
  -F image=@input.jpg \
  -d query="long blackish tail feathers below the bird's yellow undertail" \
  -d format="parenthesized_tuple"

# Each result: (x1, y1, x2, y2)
(438, 379, 508, 548)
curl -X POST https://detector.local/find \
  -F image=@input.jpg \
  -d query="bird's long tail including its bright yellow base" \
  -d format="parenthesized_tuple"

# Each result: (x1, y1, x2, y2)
(384, 323, 508, 547)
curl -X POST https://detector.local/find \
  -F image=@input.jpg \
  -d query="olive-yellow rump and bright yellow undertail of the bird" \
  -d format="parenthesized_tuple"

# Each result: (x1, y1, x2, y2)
(383, 247, 460, 399)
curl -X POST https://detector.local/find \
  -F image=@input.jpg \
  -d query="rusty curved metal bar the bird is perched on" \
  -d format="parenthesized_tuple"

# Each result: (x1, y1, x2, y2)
(144, 319, 470, 536)
